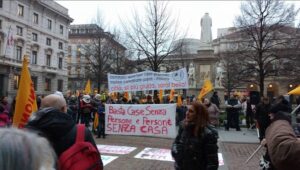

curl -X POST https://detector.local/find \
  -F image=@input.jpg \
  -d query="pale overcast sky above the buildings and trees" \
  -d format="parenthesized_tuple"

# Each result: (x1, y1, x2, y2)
(56, 0, 300, 39)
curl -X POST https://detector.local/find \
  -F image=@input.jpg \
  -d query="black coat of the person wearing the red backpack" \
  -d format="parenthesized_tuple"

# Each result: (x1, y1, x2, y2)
(26, 107, 97, 157)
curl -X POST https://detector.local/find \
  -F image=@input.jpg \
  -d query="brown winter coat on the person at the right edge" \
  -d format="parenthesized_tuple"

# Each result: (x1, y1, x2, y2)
(266, 120, 300, 170)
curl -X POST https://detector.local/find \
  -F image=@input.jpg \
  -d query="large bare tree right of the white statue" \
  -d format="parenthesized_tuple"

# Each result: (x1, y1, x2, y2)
(236, 0, 299, 96)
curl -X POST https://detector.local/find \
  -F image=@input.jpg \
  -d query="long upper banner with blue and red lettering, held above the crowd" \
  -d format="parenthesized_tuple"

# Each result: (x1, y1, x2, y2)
(107, 68, 188, 93)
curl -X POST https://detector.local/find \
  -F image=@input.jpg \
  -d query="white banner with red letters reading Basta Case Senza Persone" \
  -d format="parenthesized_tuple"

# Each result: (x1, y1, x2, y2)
(105, 104, 176, 138)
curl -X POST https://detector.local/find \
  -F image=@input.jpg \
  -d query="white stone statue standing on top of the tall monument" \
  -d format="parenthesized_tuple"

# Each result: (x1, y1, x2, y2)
(200, 13, 212, 44)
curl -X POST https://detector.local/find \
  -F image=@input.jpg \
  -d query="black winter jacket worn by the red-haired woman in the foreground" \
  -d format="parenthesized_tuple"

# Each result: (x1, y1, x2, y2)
(171, 122, 219, 170)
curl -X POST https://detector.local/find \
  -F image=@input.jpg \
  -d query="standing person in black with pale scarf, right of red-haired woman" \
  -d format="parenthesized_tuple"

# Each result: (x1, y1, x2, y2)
(225, 94, 242, 131)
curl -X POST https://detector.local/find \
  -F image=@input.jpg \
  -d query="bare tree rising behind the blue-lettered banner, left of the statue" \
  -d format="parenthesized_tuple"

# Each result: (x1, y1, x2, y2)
(123, 0, 180, 71)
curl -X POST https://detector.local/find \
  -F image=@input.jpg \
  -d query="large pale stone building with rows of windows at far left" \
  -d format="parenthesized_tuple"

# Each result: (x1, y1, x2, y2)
(0, 0, 73, 99)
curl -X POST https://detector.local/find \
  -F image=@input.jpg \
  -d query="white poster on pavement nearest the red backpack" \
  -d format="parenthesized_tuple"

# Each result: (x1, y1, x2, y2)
(97, 145, 136, 155)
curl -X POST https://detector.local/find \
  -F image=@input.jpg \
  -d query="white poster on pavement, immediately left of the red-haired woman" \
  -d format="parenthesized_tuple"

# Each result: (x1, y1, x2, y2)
(135, 148, 174, 162)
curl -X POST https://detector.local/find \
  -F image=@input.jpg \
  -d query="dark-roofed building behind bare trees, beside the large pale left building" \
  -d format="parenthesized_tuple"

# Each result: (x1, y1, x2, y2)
(67, 24, 127, 92)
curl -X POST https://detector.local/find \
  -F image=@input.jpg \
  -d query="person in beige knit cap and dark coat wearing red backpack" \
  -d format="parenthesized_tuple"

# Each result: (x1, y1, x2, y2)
(26, 94, 103, 170)
